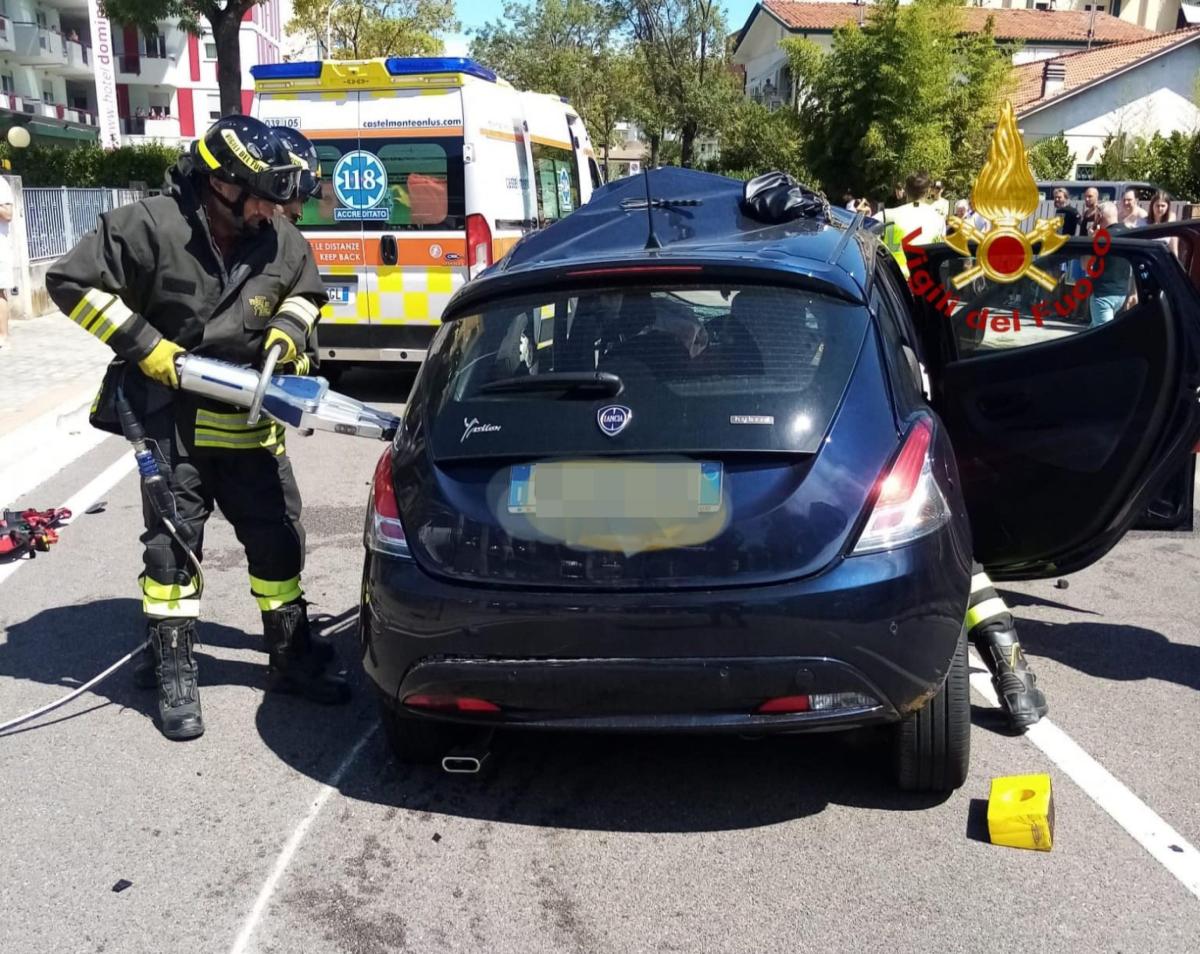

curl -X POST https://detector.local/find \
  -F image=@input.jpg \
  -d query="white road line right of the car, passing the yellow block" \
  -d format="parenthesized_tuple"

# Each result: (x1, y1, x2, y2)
(971, 650, 1200, 898)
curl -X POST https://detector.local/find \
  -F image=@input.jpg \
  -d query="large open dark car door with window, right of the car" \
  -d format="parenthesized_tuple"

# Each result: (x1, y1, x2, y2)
(912, 229, 1200, 580)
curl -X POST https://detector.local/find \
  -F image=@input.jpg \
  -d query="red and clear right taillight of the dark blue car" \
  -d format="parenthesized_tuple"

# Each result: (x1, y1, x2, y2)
(854, 418, 950, 553)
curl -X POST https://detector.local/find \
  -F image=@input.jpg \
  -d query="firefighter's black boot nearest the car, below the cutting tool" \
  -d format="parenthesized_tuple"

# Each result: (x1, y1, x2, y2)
(263, 599, 350, 706)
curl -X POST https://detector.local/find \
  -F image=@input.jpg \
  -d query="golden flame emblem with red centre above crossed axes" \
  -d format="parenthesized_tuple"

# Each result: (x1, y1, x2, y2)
(946, 102, 1068, 292)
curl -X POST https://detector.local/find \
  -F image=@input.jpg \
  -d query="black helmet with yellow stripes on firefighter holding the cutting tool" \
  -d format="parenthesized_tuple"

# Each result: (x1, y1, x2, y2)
(196, 116, 305, 203)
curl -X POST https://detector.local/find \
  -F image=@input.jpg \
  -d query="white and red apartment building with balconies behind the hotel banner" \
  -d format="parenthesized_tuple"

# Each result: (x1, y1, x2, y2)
(0, 0, 282, 144)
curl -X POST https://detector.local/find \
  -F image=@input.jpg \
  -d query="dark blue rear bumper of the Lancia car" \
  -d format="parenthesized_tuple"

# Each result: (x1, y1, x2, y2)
(360, 522, 971, 733)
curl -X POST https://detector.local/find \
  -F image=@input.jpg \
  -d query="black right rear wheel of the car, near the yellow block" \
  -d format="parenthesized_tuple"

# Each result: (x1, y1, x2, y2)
(894, 631, 971, 792)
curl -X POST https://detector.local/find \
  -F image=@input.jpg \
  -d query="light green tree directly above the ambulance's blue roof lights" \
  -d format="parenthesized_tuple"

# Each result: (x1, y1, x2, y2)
(288, 0, 458, 60)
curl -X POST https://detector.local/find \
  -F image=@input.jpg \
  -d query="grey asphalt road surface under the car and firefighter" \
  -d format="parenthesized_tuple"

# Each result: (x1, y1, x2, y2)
(0, 374, 1200, 954)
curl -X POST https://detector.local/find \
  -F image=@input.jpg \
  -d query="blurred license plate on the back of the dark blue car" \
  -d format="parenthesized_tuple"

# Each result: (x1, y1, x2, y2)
(508, 461, 722, 518)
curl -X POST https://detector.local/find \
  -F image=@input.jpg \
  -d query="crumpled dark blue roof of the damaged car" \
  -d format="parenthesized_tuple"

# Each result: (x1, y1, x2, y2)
(448, 167, 874, 313)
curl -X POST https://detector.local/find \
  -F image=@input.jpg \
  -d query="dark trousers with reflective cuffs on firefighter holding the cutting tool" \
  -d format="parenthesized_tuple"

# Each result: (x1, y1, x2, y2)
(140, 409, 305, 619)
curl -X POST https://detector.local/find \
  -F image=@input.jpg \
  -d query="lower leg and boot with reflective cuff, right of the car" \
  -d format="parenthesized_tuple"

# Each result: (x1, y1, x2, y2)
(967, 565, 1050, 732)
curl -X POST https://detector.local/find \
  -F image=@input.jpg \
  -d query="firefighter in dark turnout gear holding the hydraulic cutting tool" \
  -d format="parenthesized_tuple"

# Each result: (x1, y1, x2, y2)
(46, 116, 349, 739)
